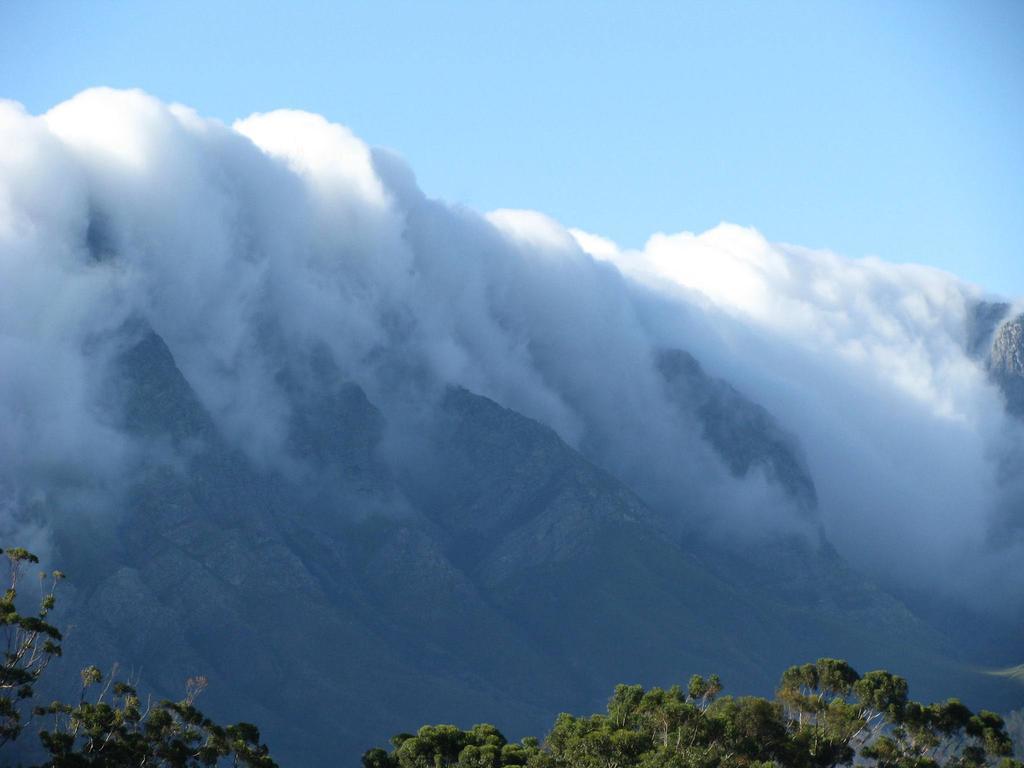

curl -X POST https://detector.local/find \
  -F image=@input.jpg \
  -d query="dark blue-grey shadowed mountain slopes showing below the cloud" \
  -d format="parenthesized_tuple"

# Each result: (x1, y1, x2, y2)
(16, 328, 1015, 766)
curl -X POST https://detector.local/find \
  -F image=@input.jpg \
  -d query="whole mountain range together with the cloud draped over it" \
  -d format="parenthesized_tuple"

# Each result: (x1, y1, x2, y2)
(0, 89, 1024, 761)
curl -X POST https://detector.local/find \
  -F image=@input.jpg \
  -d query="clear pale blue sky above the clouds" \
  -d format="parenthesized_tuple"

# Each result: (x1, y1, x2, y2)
(6, 0, 1024, 295)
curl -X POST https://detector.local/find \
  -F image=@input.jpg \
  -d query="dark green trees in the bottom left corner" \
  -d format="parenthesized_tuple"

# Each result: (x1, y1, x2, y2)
(0, 548, 278, 768)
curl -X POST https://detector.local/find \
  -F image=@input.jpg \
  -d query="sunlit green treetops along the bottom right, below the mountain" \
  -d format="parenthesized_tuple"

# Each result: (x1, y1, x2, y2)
(362, 658, 1024, 768)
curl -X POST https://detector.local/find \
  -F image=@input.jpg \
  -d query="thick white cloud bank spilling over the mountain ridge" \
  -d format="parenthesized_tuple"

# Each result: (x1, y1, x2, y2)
(0, 89, 1024, 611)
